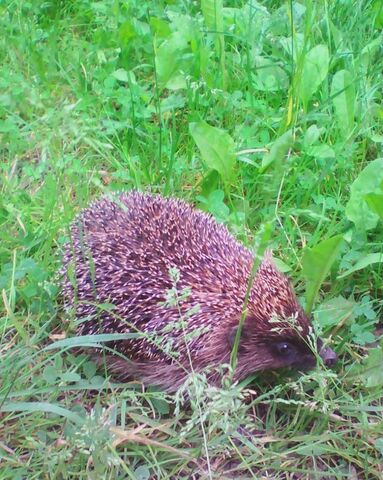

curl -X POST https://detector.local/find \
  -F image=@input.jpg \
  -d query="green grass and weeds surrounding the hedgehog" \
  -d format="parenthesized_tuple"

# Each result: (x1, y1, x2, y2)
(0, 0, 383, 480)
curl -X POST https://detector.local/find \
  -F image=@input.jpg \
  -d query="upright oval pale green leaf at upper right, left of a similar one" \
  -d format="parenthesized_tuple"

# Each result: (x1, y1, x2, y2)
(299, 45, 329, 110)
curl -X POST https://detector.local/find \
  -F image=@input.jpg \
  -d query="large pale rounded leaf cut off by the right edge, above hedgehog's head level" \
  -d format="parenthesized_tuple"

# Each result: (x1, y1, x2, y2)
(346, 158, 383, 230)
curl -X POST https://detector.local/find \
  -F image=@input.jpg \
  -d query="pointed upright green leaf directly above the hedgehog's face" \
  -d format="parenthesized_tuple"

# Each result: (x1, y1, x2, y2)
(302, 235, 343, 314)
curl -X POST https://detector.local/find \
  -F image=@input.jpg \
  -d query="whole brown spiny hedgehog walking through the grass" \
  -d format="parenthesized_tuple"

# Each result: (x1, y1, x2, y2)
(62, 191, 336, 391)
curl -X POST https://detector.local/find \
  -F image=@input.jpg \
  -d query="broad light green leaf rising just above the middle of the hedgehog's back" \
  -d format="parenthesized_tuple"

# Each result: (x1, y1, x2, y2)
(189, 121, 235, 181)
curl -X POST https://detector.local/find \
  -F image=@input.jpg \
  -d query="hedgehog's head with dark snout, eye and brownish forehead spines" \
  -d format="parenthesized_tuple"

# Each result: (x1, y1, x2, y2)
(231, 258, 336, 378)
